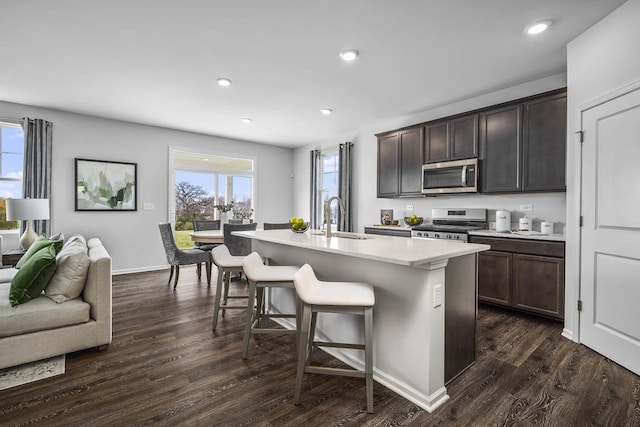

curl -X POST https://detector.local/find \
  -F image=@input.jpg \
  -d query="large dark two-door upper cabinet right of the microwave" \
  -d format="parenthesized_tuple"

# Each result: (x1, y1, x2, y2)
(480, 90, 567, 193)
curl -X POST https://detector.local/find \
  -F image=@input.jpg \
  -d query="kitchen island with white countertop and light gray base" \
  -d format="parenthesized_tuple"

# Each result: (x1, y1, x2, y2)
(234, 230, 489, 412)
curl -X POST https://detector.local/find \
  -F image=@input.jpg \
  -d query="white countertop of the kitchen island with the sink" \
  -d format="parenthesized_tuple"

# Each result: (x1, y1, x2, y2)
(233, 230, 490, 266)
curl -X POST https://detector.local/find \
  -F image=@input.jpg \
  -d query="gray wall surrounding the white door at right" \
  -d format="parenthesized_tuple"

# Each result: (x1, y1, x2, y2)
(564, 0, 640, 340)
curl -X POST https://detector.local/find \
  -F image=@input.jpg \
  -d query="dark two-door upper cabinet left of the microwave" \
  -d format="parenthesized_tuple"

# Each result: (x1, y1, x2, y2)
(378, 127, 424, 197)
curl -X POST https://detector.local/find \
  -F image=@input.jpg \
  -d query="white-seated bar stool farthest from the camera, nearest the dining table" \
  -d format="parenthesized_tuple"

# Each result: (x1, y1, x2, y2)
(211, 245, 248, 331)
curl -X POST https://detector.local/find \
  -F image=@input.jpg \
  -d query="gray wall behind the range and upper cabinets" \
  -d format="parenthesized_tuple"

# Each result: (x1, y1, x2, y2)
(294, 74, 566, 232)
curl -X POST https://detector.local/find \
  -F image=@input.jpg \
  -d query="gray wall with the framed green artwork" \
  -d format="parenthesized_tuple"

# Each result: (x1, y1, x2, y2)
(0, 102, 292, 273)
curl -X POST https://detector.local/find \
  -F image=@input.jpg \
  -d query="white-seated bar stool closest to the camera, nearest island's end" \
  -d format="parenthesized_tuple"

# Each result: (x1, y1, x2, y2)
(293, 264, 375, 414)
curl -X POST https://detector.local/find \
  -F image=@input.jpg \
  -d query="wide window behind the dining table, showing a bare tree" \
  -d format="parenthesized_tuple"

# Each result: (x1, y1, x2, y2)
(170, 150, 254, 247)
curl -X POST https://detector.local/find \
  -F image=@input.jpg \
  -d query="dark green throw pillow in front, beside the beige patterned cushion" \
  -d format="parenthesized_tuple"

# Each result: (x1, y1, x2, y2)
(9, 245, 56, 307)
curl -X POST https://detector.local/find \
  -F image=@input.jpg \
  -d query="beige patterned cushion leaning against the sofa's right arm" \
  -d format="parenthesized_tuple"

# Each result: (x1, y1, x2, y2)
(44, 235, 90, 303)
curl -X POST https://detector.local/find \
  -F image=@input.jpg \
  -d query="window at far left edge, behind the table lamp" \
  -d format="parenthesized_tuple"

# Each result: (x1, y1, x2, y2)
(0, 122, 24, 230)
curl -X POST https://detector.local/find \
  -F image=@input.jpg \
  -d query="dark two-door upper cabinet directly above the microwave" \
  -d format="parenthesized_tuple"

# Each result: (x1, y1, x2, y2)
(424, 114, 478, 163)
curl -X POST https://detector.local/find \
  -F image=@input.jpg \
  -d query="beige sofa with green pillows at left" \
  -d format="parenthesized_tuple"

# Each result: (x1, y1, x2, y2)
(0, 238, 112, 369)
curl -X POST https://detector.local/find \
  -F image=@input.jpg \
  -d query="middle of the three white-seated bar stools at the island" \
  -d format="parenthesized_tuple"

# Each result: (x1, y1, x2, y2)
(242, 252, 298, 359)
